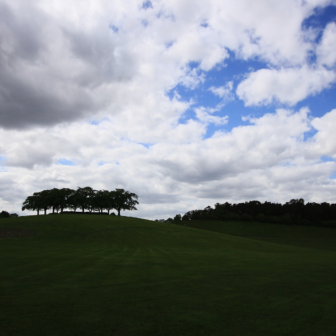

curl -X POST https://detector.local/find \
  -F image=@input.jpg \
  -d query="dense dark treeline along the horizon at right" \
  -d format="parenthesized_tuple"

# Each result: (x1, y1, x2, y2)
(159, 198, 336, 227)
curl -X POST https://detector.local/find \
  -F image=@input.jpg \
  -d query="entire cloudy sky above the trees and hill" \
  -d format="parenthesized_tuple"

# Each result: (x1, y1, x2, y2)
(0, 0, 336, 219)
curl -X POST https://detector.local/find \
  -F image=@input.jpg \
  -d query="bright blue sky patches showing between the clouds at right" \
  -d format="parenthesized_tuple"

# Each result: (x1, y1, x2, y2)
(173, 6, 336, 138)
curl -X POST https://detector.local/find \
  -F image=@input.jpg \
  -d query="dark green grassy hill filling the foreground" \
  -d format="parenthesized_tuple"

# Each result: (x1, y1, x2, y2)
(0, 215, 336, 336)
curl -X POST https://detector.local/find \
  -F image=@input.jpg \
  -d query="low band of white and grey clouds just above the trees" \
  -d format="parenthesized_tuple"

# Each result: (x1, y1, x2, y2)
(0, 109, 336, 218)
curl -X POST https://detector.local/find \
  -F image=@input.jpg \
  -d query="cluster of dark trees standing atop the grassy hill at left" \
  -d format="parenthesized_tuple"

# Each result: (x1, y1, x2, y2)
(22, 187, 139, 216)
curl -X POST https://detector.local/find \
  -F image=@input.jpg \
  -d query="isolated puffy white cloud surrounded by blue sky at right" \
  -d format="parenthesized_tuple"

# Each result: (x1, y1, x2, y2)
(237, 66, 336, 106)
